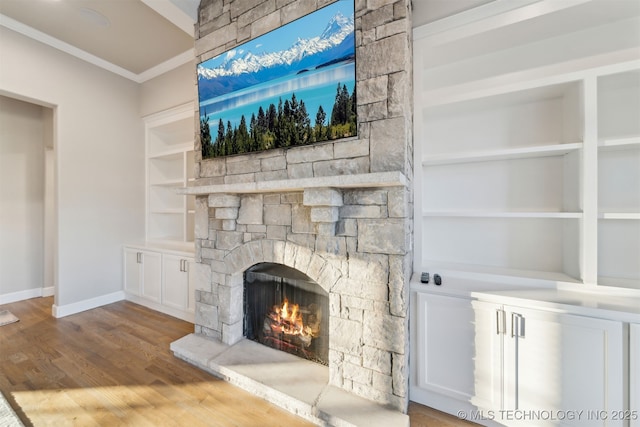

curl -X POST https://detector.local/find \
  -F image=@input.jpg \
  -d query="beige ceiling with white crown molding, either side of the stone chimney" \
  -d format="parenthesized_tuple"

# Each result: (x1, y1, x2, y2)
(0, 0, 495, 82)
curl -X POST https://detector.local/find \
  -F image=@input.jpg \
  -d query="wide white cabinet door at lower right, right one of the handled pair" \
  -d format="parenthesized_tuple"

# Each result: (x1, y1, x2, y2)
(504, 307, 625, 426)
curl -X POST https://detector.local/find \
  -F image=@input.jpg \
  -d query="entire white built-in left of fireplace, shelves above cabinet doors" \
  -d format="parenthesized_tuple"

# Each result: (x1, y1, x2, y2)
(123, 103, 195, 322)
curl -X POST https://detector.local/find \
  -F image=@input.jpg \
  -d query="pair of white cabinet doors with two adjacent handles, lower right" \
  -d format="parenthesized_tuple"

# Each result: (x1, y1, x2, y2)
(472, 301, 631, 426)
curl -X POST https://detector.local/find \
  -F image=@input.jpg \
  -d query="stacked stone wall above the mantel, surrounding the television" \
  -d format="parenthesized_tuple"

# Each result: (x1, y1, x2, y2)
(196, 0, 413, 185)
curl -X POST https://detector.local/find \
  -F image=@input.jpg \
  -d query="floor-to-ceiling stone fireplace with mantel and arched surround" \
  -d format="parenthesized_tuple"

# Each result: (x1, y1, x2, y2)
(174, 0, 413, 422)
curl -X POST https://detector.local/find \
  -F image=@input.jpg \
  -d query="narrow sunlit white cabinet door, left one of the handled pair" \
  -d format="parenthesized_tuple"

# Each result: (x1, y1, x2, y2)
(471, 301, 505, 411)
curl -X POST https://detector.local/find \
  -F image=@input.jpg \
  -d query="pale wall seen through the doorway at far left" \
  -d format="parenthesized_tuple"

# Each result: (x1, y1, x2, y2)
(0, 96, 45, 302)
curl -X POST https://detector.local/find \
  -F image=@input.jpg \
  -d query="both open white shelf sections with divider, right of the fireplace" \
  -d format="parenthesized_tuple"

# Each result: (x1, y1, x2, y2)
(416, 57, 640, 289)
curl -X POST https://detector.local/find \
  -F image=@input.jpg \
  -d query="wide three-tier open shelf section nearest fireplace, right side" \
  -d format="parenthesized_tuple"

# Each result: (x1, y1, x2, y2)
(417, 80, 584, 284)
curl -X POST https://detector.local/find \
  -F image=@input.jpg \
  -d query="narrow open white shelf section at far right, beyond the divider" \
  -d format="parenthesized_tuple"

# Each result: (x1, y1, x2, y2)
(598, 69, 640, 289)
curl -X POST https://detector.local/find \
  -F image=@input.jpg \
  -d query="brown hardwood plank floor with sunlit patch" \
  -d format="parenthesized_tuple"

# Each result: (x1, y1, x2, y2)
(0, 297, 476, 427)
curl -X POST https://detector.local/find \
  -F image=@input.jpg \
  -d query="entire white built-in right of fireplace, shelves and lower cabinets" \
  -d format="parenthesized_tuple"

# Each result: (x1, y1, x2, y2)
(410, 0, 640, 426)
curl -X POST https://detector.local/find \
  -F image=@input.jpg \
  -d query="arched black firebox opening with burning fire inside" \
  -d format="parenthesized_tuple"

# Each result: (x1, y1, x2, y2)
(244, 263, 329, 365)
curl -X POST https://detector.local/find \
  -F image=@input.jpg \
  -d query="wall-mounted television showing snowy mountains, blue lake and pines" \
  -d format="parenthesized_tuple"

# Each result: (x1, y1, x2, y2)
(197, 0, 357, 159)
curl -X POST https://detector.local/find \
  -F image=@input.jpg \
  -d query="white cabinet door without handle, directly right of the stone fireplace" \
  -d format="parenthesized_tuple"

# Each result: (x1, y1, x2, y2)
(416, 293, 474, 402)
